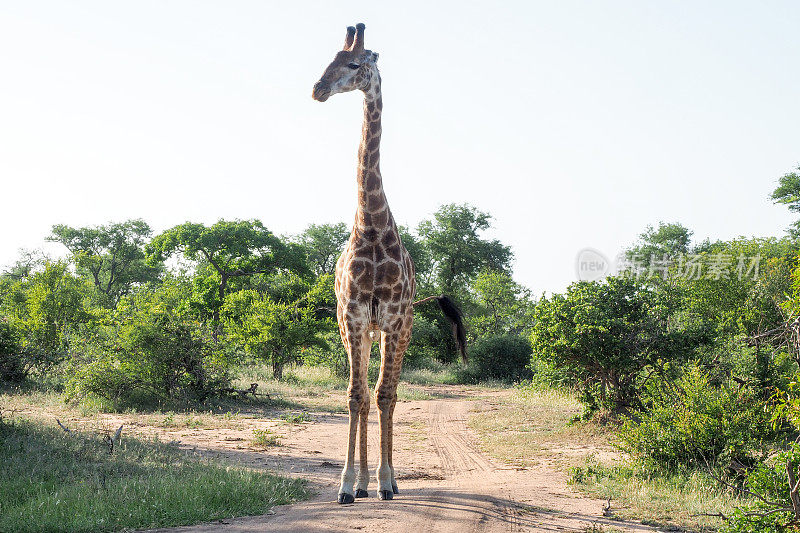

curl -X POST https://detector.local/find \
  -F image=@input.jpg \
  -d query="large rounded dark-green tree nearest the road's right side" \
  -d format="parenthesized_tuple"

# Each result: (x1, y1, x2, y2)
(531, 276, 704, 411)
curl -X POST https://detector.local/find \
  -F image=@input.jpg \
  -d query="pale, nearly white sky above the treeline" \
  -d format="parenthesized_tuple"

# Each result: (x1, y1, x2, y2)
(0, 0, 800, 293)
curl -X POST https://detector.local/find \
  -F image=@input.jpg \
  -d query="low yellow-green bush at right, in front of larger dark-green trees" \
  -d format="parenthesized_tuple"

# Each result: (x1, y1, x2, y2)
(619, 365, 774, 469)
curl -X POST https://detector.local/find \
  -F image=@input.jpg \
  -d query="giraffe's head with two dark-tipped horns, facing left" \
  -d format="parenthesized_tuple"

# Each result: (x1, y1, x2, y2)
(311, 23, 379, 102)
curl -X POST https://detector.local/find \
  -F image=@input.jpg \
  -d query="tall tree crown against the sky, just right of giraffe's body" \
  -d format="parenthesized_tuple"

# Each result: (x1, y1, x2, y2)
(418, 204, 513, 294)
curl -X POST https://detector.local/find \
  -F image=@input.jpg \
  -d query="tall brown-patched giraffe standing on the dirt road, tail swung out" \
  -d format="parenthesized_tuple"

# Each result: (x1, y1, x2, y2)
(312, 24, 466, 504)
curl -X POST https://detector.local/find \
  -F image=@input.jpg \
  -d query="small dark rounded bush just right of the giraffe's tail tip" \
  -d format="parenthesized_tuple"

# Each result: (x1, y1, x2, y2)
(462, 335, 531, 381)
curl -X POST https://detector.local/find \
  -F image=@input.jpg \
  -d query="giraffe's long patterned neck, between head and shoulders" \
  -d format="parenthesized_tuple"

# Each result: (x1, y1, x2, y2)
(355, 71, 391, 231)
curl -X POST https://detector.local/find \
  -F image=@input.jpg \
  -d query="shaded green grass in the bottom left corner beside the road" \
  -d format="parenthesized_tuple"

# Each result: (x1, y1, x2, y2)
(0, 419, 307, 532)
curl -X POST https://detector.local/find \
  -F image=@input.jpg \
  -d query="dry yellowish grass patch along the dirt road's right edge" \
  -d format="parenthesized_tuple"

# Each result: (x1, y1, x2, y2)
(469, 387, 747, 531)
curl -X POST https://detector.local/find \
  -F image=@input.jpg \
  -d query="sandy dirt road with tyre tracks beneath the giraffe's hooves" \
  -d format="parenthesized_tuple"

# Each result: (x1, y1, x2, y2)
(145, 387, 655, 533)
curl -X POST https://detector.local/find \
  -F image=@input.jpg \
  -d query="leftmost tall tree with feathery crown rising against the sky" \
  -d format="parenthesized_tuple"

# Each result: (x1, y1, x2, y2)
(48, 219, 160, 308)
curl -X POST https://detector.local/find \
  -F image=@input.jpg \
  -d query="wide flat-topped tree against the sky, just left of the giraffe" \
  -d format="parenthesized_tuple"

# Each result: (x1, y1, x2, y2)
(146, 220, 309, 331)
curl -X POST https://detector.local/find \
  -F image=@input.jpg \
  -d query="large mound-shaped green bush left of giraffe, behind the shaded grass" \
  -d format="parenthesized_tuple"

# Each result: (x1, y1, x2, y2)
(66, 279, 231, 405)
